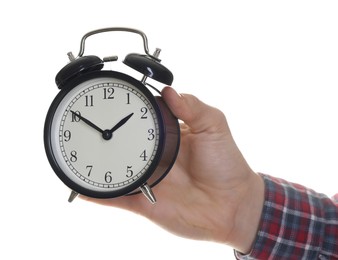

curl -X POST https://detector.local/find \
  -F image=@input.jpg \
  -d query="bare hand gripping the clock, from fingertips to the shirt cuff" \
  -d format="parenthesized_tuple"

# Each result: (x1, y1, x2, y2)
(82, 87, 264, 253)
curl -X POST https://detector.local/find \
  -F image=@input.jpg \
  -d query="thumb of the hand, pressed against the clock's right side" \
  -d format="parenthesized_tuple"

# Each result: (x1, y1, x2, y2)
(162, 87, 228, 132)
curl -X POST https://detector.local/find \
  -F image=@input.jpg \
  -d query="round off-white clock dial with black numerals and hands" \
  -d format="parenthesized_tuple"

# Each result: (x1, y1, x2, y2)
(50, 73, 162, 197)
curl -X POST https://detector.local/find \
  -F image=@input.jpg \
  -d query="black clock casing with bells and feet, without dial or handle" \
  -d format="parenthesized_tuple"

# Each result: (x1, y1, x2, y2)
(44, 29, 180, 203)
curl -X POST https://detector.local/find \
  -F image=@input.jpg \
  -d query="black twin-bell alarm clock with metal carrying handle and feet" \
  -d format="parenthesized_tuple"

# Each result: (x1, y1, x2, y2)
(44, 27, 180, 203)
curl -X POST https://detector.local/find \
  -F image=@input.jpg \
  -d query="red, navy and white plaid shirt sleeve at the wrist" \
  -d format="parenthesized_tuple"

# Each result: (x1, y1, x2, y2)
(235, 174, 338, 260)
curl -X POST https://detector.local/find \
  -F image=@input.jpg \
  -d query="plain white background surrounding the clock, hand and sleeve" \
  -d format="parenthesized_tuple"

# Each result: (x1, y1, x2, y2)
(0, 0, 338, 260)
